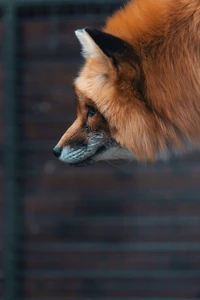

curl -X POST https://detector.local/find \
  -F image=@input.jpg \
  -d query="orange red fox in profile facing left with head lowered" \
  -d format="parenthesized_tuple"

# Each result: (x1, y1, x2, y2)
(54, 0, 200, 166)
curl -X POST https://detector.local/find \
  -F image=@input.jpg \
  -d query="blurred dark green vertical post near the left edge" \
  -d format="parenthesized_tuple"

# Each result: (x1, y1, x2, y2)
(3, 1, 19, 300)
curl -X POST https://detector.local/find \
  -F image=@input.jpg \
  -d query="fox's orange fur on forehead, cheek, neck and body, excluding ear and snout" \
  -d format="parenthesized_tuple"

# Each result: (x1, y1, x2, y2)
(56, 0, 200, 161)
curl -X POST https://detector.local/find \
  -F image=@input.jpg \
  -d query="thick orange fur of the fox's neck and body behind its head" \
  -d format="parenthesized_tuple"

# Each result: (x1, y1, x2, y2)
(104, 0, 200, 157)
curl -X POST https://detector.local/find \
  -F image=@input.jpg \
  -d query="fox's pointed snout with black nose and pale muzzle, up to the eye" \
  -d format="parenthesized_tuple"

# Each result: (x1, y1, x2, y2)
(53, 107, 114, 166)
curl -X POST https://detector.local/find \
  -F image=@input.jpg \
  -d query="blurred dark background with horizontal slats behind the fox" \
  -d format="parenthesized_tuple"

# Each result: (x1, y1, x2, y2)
(0, 0, 200, 300)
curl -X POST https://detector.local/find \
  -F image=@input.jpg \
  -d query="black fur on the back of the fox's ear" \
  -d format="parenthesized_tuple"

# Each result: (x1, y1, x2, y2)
(85, 28, 132, 57)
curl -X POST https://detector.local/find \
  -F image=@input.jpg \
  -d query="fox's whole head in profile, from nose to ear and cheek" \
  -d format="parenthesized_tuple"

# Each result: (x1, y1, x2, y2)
(54, 28, 153, 166)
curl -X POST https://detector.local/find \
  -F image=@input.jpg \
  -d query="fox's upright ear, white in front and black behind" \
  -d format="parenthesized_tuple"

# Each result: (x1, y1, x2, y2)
(75, 28, 131, 59)
